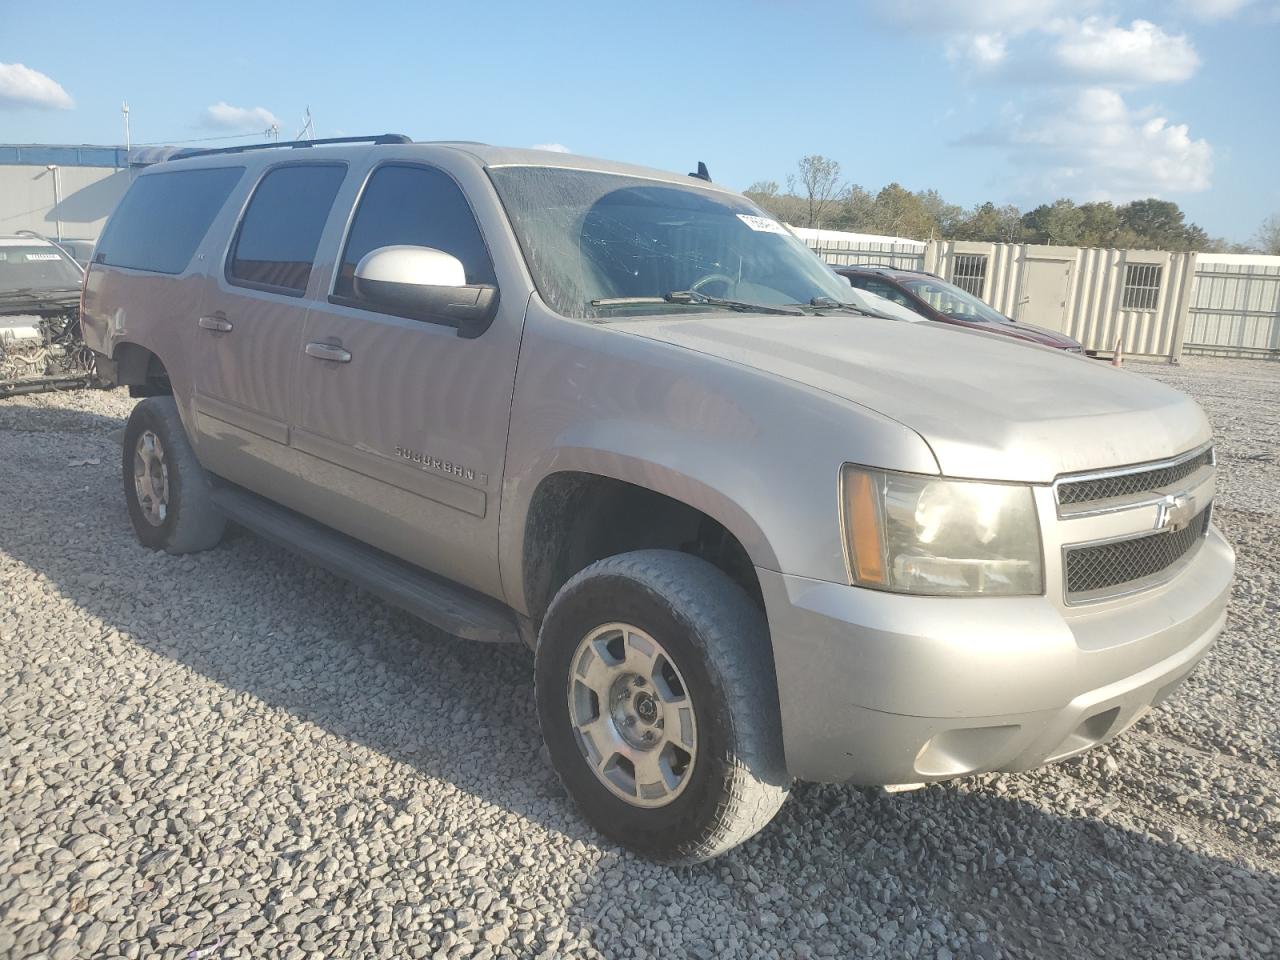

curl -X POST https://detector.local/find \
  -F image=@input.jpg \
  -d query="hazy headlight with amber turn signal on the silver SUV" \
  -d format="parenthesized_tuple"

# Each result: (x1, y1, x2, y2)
(840, 465, 1044, 596)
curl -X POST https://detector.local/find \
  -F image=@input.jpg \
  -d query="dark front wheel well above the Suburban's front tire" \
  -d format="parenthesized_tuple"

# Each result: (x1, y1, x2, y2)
(524, 472, 764, 623)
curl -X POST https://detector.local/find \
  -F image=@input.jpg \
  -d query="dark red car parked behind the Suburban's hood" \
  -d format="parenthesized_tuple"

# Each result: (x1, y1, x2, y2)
(832, 266, 1084, 353)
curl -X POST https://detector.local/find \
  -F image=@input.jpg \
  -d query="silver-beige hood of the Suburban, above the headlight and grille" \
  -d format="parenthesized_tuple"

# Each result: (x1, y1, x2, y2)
(609, 314, 1210, 483)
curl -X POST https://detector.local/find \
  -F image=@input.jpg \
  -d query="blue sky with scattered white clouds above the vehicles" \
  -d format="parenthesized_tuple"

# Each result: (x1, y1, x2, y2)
(0, 0, 1280, 242)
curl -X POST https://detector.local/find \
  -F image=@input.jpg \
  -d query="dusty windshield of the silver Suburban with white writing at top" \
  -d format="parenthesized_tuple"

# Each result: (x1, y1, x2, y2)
(489, 166, 851, 317)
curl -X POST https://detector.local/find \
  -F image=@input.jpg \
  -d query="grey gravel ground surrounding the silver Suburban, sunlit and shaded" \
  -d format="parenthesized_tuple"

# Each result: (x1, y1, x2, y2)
(0, 360, 1280, 960)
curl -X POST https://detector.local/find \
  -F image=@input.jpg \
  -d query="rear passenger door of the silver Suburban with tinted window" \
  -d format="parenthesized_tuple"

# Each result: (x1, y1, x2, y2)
(193, 161, 347, 503)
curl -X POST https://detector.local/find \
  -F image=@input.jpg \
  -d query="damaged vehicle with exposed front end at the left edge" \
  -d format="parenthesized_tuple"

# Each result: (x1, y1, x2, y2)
(0, 233, 109, 398)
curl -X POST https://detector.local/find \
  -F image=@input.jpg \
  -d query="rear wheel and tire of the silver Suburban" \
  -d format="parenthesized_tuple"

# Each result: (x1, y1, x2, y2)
(122, 397, 227, 553)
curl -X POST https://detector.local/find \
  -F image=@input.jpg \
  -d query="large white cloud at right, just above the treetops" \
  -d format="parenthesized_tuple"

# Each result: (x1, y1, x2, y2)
(965, 87, 1213, 201)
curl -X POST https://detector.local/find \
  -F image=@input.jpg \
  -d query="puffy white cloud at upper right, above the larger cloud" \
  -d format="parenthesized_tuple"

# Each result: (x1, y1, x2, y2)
(1048, 17, 1199, 83)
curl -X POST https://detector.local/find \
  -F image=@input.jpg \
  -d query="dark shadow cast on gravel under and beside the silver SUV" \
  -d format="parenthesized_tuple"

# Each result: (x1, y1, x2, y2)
(0, 394, 1280, 957)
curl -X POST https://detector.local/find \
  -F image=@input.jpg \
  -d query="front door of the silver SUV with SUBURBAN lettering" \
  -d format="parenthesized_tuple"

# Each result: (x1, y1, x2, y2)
(293, 161, 525, 596)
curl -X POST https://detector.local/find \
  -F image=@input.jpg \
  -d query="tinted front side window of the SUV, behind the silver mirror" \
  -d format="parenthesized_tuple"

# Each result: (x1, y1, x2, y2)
(334, 165, 497, 297)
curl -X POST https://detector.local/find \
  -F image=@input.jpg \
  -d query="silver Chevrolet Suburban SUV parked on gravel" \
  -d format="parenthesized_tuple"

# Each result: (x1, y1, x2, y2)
(77, 136, 1234, 860)
